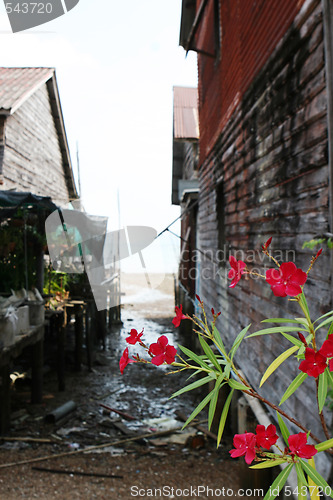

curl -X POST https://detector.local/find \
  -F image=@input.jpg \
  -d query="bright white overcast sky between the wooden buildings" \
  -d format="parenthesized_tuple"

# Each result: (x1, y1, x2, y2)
(0, 0, 197, 274)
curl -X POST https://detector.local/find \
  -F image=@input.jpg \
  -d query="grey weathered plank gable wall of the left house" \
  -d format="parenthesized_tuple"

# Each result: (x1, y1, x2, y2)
(3, 84, 69, 205)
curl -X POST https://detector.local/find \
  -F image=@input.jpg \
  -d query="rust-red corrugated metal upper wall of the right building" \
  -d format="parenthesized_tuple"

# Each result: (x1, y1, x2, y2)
(197, 0, 305, 161)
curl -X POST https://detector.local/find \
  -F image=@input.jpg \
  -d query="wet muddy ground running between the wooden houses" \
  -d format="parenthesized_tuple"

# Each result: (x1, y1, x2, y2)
(0, 276, 262, 500)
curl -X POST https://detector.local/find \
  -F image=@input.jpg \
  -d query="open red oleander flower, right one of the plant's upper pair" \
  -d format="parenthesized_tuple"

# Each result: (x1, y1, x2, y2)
(266, 262, 308, 297)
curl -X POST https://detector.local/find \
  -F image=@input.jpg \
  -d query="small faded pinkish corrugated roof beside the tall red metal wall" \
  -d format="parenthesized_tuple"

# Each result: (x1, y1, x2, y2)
(173, 87, 199, 139)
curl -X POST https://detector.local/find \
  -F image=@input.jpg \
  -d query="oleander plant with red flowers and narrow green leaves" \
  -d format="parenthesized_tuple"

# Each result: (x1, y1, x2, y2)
(119, 238, 333, 500)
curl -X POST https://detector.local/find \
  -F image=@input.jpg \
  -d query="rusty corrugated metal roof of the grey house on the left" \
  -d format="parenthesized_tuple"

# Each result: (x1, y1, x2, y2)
(0, 67, 54, 113)
